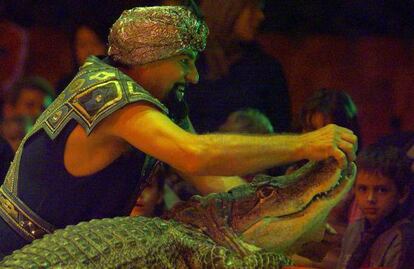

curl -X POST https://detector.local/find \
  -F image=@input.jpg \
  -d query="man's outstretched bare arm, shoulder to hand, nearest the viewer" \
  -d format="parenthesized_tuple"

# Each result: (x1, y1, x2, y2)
(107, 103, 356, 176)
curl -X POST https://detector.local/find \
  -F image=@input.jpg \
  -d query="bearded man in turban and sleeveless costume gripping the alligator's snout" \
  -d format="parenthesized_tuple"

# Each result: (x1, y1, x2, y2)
(0, 7, 356, 254)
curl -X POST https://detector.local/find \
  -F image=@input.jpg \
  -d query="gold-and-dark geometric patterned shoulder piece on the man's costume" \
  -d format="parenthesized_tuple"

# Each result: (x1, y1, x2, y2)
(33, 57, 168, 139)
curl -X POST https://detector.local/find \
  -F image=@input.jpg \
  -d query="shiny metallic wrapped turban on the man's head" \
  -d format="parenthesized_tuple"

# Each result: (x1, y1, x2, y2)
(108, 6, 208, 65)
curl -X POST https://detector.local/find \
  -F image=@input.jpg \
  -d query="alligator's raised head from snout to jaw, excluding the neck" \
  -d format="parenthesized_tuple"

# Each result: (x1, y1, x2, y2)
(233, 159, 356, 252)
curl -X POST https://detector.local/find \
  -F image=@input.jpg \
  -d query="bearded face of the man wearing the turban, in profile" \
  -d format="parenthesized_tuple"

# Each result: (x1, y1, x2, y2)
(136, 51, 199, 100)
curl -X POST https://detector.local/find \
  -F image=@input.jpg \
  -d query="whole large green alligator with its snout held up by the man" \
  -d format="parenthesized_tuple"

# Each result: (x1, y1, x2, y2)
(0, 159, 356, 268)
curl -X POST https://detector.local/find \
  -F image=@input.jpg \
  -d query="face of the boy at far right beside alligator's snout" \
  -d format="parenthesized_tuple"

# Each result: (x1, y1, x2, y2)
(354, 170, 406, 225)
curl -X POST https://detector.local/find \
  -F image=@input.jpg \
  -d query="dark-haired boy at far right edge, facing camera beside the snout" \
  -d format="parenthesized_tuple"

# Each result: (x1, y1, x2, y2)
(337, 144, 414, 269)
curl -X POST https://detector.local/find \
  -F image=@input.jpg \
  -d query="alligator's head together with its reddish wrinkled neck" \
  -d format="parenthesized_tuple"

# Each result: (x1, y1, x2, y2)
(172, 159, 356, 255)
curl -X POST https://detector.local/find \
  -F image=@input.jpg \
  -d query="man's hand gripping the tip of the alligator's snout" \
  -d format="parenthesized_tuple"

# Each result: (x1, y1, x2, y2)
(301, 124, 358, 167)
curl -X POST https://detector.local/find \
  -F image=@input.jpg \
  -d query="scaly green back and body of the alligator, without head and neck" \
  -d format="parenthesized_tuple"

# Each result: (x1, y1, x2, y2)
(0, 217, 289, 269)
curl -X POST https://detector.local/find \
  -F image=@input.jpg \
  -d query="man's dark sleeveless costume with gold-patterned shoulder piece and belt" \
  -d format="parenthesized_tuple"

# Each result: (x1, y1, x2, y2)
(0, 56, 168, 247)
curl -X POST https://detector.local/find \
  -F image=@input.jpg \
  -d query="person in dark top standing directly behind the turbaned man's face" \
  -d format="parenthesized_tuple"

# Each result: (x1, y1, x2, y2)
(167, 0, 290, 133)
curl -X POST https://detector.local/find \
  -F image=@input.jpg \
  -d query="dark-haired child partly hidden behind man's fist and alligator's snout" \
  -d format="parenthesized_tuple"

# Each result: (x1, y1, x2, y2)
(286, 88, 361, 268)
